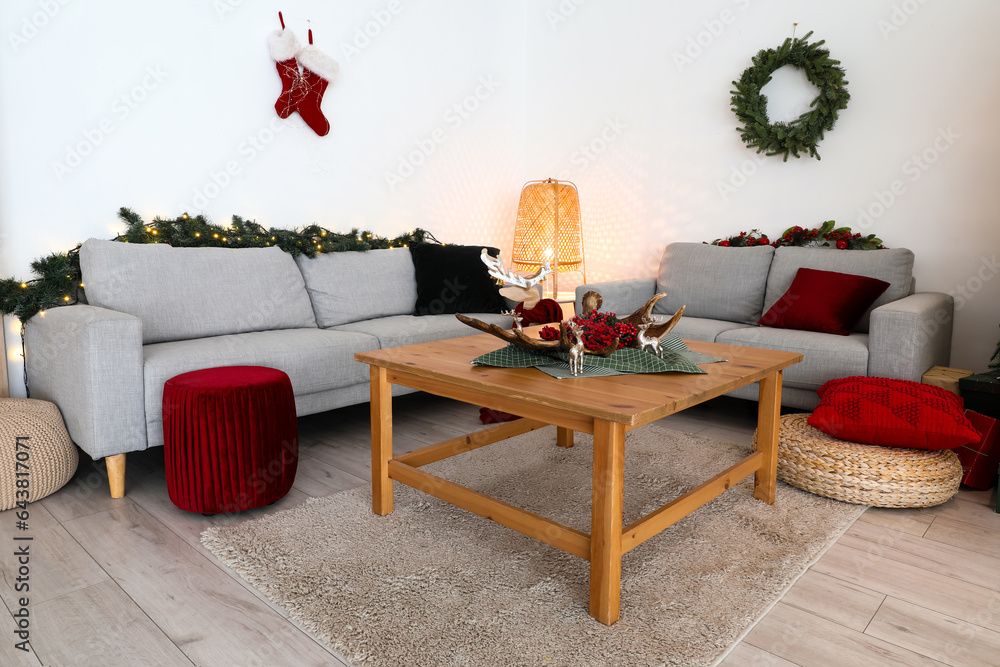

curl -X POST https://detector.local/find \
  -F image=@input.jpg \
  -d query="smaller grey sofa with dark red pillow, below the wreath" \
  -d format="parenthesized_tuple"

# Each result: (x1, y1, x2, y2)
(576, 243, 954, 410)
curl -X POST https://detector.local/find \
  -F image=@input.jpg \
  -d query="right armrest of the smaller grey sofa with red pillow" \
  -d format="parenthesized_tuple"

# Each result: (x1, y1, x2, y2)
(868, 292, 955, 382)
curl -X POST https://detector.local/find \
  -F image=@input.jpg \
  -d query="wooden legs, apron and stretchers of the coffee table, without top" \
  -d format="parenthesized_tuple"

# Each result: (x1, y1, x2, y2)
(359, 355, 795, 625)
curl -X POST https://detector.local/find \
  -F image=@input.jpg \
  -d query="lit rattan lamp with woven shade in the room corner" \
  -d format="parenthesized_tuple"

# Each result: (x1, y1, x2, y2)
(512, 178, 587, 301)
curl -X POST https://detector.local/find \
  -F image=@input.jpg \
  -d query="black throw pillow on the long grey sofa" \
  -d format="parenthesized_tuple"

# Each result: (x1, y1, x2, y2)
(410, 243, 507, 315)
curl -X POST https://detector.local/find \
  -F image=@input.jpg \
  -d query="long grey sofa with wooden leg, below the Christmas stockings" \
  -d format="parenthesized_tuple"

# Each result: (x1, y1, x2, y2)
(25, 239, 511, 496)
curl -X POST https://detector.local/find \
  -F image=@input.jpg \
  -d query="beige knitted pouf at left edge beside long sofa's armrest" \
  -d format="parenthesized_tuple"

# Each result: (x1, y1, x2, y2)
(0, 398, 79, 510)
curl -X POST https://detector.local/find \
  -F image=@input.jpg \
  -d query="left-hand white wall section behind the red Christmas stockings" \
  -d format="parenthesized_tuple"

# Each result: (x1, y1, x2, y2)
(0, 0, 525, 391)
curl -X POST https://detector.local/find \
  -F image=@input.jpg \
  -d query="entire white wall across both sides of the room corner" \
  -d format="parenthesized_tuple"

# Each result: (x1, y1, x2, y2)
(0, 0, 1000, 394)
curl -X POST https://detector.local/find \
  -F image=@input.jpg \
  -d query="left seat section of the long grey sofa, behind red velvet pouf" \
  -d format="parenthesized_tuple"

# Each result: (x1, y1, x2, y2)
(142, 327, 378, 447)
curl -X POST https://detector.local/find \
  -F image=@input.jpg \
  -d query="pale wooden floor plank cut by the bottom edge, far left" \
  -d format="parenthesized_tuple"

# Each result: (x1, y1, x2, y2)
(32, 581, 193, 667)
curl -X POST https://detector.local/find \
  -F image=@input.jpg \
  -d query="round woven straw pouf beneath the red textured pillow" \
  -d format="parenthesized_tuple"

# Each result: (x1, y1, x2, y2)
(754, 414, 962, 507)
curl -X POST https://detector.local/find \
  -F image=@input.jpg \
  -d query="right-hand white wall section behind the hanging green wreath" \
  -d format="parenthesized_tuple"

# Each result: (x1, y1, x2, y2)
(525, 0, 1000, 370)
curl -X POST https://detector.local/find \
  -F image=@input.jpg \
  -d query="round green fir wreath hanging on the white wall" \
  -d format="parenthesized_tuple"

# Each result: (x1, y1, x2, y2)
(730, 32, 851, 162)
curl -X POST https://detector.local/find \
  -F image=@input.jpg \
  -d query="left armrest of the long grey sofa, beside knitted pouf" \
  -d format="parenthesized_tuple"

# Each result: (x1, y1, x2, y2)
(24, 305, 147, 459)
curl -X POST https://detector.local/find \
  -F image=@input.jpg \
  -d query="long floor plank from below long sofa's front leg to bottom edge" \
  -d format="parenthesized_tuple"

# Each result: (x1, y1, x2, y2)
(64, 499, 346, 665)
